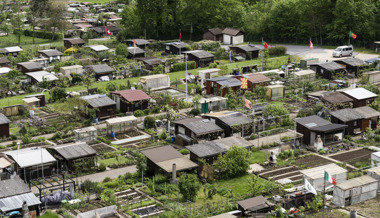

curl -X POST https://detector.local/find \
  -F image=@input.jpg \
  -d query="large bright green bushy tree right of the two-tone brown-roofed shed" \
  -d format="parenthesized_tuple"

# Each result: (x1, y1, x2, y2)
(215, 146, 250, 179)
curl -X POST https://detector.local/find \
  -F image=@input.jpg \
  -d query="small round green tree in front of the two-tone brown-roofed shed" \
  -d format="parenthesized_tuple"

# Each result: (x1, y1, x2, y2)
(178, 173, 201, 202)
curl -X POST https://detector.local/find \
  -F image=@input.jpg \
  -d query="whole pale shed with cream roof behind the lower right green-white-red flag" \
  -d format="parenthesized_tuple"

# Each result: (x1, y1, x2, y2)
(300, 163, 347, 191)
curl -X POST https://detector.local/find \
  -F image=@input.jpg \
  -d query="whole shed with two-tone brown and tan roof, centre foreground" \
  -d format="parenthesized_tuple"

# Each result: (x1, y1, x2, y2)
(141, 145, 198, 176)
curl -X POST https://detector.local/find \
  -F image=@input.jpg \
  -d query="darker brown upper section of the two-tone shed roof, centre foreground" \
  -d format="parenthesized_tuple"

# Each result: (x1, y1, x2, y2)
(141, 145, 183, 163)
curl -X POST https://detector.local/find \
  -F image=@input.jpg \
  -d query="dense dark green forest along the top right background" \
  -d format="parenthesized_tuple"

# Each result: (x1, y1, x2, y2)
(119, 0, 380, 47)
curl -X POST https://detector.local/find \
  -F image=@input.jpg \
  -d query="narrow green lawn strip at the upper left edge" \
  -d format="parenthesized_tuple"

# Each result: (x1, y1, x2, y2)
(0, 34, 63, 50)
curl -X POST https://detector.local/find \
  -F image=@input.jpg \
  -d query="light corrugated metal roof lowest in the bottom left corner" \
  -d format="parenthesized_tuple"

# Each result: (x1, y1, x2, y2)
(0, 193, 41, 212)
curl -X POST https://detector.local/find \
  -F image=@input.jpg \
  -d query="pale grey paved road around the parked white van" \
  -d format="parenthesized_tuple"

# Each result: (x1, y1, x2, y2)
(255, 44, 378, 61)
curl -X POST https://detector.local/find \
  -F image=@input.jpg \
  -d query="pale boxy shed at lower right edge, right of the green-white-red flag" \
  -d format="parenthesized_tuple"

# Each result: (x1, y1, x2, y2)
(332, 175, 378, 207)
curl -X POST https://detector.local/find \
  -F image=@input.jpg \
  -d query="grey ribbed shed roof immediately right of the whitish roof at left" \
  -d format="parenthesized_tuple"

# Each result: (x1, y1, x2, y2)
(51, 142, 96, 160)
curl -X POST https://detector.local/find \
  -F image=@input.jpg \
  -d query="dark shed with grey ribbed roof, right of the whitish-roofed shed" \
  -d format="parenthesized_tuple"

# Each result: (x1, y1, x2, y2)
(47, 142, 96, 172)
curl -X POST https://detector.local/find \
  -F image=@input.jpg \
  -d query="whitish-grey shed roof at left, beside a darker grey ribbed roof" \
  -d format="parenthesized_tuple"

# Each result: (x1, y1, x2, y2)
(3, 147, 56, 168)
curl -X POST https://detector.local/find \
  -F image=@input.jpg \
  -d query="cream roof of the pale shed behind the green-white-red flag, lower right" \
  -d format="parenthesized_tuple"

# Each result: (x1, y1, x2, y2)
(300, 163, 347, 179)
